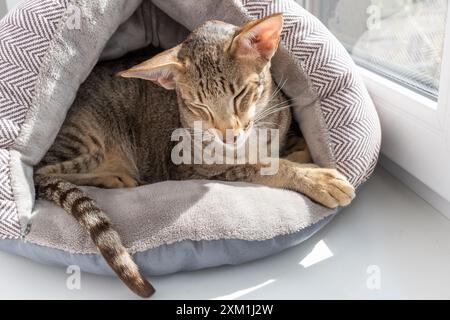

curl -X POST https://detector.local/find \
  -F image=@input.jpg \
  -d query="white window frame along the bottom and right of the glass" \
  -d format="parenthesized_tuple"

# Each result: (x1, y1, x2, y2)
(297, 0, 450, 202)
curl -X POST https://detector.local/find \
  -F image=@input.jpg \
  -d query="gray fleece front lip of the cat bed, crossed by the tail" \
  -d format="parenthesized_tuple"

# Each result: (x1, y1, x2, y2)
(26, 180, 336, 253)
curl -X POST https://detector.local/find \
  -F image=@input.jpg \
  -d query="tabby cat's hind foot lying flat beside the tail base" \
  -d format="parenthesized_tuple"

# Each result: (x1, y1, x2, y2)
(40, 172, 139, 189)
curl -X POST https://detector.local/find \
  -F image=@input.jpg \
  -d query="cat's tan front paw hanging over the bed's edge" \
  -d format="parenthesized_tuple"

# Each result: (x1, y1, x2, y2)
(304, 168, 355, 208)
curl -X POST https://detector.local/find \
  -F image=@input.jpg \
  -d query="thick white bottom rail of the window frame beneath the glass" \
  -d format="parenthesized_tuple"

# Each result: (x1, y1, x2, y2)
(358, 67, 450, 218)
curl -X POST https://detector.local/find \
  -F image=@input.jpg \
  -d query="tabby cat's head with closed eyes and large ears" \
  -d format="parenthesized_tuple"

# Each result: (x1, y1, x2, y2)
(119, 14, 283, 141)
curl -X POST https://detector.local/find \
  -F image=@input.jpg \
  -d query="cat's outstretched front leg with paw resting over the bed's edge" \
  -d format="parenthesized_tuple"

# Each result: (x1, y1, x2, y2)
(219, 159, 355, 208)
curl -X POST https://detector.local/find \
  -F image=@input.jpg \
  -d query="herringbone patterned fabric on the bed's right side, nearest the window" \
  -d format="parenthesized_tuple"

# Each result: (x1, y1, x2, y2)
(241, 0, 381, 186)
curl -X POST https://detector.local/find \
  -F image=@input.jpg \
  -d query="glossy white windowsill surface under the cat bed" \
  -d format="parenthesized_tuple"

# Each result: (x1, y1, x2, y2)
(0, 168, 450, 298)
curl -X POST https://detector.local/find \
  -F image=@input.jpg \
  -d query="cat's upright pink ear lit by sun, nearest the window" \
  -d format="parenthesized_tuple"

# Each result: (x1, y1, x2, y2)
(231, 13, 283, 60)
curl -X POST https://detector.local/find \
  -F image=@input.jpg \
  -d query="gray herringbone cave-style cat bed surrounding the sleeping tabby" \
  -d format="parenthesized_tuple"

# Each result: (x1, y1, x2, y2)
(0, 0, 380, 275)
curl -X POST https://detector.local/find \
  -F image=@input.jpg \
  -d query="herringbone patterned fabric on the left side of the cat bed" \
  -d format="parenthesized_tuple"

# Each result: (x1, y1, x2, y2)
(0, 0, 68, 239)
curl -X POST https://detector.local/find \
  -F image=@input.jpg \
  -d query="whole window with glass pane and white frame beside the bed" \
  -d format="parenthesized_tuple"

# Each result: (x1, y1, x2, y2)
(297, 0, 450, 212)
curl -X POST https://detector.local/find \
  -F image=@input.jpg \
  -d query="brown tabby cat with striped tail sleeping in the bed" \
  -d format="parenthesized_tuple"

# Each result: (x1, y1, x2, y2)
(35, 14, 355, 297)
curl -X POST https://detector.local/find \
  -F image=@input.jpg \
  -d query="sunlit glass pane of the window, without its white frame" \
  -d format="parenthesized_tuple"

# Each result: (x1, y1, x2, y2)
(316, 0, 448, 100)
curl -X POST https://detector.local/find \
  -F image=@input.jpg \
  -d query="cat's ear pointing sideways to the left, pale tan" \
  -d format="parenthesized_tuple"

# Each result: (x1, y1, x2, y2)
(117, 45, 183, 90)
